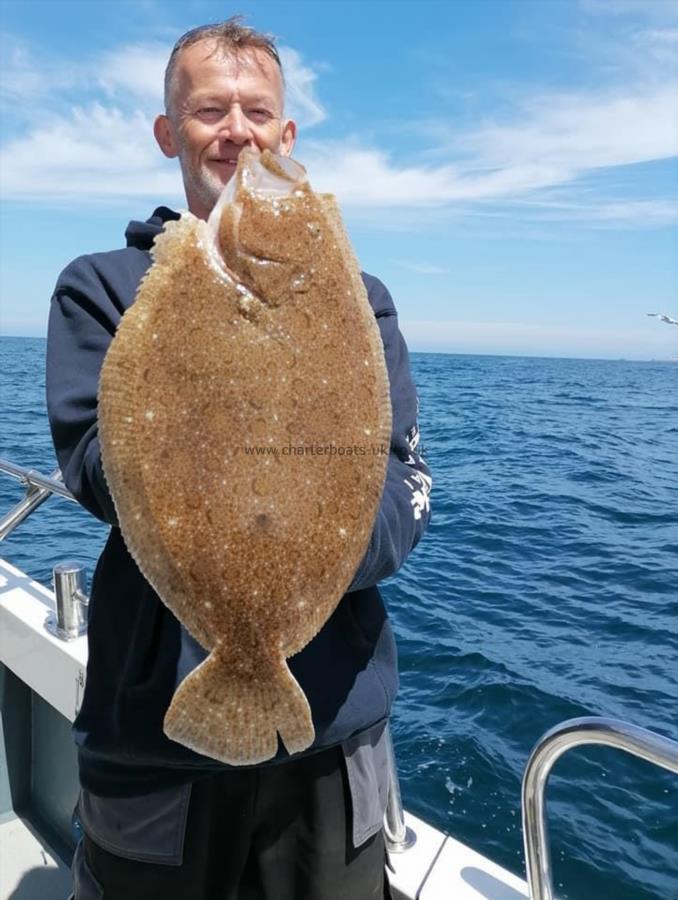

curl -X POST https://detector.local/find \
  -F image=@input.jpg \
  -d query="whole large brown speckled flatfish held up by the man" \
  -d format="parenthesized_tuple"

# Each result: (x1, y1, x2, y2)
(98, 151, 391, 765)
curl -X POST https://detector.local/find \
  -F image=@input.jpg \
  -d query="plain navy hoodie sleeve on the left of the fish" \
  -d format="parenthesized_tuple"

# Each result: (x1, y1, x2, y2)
(47, 257, 128, 525)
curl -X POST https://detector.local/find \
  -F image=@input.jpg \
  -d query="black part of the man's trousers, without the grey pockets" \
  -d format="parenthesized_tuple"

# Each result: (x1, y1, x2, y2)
(75, 750, 391, 900)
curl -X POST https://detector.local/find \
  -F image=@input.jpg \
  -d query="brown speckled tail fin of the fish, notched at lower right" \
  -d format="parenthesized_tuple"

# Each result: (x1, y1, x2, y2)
(164, 649, 315, 766)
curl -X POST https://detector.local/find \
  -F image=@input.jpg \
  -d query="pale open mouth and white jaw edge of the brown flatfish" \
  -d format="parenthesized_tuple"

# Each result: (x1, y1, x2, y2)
(207, 148, 306, 287)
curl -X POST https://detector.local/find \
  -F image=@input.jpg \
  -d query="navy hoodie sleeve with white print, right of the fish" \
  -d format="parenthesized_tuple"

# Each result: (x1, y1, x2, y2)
(348, 278, 431, 592)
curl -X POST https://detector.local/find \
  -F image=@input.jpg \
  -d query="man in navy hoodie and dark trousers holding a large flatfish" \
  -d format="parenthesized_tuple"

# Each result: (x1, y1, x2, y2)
(47, 19, 430, 900)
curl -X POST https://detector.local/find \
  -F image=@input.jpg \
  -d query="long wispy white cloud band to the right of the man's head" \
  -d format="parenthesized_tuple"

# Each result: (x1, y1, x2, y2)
(306, 75, 678, 218)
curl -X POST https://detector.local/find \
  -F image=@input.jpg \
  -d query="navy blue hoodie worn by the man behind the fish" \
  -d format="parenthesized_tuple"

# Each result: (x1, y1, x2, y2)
(47, 207, 431, 796)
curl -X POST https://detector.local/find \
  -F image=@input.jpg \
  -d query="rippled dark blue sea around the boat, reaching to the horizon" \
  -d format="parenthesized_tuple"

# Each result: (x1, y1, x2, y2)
(0, 338, 678, 900)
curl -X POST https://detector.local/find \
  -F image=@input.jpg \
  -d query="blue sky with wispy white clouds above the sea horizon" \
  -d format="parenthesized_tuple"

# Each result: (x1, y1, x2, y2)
(0, 0, 678, 359)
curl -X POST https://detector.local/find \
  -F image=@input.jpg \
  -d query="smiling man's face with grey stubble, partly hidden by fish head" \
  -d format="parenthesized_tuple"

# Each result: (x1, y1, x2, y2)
(154, 40, 296, 219)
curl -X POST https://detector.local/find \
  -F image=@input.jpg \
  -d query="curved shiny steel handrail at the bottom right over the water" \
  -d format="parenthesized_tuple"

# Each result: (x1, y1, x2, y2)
(522, 716, 678, 900)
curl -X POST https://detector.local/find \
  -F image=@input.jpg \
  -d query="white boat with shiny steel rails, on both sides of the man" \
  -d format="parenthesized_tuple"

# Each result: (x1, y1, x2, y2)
(0, 459, 678, 900)
